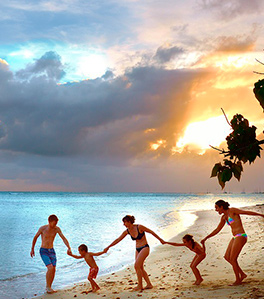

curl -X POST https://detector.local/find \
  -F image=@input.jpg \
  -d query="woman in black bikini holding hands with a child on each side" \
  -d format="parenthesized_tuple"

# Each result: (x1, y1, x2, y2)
(105, 215, 165, 291)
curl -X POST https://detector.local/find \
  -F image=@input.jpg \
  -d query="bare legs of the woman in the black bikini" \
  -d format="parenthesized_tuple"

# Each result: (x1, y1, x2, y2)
(134, 247, 153, 291)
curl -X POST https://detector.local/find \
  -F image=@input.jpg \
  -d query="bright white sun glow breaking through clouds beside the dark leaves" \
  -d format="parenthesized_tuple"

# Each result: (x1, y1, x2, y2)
(172, 116, 231, 155)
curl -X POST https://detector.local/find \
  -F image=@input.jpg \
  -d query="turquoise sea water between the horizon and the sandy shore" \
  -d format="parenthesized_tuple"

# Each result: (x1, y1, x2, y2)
(0, 192, 264, 299)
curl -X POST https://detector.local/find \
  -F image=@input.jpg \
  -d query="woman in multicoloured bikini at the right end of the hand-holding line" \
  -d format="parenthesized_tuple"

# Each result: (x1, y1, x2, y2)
(201, 200, 264, 285)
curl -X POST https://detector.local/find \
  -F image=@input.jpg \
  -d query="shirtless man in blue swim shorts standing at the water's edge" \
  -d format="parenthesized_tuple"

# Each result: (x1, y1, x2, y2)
(30, 215, 71, 294)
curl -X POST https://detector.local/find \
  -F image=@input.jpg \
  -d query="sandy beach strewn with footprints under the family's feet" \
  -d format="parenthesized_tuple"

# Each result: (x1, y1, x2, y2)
(34, 205, 264, 299)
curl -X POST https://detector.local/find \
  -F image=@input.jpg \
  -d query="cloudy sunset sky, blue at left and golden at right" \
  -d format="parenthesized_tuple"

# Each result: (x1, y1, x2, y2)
(0, 0, 264, 193)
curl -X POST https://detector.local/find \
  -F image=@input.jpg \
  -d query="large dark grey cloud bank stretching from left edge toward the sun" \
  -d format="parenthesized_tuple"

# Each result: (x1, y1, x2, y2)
(0, 52, 207, 159)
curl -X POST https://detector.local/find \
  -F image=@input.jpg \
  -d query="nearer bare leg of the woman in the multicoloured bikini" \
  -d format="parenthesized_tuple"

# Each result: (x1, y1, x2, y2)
(229, 236, 247, 285)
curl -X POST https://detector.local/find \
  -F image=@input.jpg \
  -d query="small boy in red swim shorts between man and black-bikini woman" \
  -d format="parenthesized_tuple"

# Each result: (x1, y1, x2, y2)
(67, 244, 106, 293)
